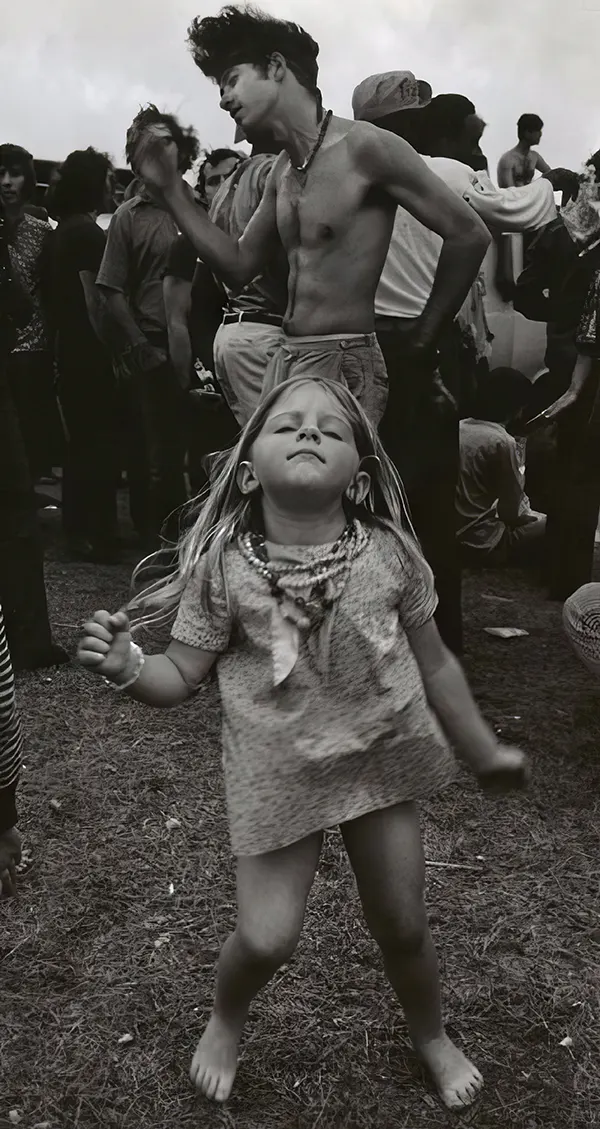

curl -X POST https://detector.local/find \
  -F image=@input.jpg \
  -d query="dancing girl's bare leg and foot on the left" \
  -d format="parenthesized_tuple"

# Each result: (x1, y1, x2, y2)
(190, 833, 322, 1102)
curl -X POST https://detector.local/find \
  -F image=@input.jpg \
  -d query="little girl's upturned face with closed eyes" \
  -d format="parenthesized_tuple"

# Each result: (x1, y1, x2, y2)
(250, 382, 360, 509)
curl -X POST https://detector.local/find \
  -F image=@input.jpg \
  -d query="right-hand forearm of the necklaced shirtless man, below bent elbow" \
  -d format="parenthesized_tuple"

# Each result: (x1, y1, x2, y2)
(419, 229, 490, 344)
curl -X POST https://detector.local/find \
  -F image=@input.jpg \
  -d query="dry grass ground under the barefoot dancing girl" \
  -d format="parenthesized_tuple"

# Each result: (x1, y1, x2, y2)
(0, 519, 600, 1129)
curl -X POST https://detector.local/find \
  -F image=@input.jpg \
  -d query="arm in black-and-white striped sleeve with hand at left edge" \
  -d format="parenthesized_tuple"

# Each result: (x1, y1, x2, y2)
(0, 606, 23, 896)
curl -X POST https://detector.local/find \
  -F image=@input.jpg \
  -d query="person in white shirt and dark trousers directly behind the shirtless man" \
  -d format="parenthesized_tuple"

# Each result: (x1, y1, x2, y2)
(353, 76, 556, 654)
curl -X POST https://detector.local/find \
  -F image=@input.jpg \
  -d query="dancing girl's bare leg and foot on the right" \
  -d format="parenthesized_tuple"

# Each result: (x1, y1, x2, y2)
(341, 804, 482, 1109)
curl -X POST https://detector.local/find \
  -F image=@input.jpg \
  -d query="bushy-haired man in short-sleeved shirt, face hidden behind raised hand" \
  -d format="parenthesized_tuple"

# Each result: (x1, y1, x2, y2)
(96, 106, 199, 545)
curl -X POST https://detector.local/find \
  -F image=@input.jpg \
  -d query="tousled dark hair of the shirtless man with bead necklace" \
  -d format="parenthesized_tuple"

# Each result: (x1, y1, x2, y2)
(188, 5, 320, 102)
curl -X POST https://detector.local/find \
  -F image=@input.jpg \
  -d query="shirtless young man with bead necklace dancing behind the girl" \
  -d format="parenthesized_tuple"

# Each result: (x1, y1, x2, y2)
(131, 7, 489, 425)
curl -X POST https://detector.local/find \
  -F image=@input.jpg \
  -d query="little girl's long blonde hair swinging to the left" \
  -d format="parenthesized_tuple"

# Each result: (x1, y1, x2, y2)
(128, 376, 417, 628)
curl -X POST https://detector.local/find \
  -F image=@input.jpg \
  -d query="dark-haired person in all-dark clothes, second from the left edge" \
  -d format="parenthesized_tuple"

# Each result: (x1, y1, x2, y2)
(52, 148, 119, 560)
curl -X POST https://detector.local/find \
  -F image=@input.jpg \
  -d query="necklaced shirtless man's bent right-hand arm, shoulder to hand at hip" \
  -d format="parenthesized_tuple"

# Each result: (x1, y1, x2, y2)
(359, 128, 490, 349)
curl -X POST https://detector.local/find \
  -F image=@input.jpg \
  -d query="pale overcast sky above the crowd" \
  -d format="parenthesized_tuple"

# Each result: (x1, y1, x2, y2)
(0, 0, 600, 178)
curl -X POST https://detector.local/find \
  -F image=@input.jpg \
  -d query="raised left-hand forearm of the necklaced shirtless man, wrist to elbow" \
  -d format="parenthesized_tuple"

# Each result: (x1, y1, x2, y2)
(165, 182, 249, 287)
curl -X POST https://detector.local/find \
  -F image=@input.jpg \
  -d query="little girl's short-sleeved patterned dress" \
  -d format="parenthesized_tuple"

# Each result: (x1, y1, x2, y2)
(172, 528, 456, 856)
